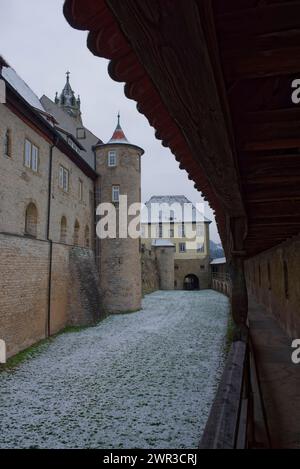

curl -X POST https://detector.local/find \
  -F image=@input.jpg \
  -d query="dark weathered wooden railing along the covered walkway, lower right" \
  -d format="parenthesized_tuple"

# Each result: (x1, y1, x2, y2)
(200, 341, 271, 449)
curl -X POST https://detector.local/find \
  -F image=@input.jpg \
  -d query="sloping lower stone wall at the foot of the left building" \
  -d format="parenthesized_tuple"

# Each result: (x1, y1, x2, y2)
(0, 234, 103, 357)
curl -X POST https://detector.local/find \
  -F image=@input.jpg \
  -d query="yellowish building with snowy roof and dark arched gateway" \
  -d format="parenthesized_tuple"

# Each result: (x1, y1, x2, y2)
(142, 195, 211, 290)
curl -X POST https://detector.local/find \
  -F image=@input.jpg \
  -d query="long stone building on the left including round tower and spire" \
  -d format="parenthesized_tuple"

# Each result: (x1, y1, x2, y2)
(0, 58, 143, 356)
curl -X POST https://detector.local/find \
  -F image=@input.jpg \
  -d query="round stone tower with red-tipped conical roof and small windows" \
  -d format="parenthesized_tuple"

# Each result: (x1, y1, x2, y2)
(95, 115, 144, 313)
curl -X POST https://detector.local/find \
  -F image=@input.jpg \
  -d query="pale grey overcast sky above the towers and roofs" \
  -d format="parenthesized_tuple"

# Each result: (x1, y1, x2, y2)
(0, 0, 219, 241)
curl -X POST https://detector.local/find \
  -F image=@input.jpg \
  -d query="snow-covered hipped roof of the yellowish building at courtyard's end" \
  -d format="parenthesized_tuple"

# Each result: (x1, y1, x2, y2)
(141, 195, 211, 223)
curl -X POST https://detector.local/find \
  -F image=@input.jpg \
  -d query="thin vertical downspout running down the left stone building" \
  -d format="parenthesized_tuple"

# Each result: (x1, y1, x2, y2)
(46, 138, 58, 337)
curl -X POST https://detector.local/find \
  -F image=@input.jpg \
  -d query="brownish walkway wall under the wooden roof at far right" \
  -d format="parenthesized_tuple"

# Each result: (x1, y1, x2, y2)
(246, 237, 300, 338)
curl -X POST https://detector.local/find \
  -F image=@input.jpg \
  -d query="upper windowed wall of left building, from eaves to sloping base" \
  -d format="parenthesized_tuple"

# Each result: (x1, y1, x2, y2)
(0, 105, 94, 246)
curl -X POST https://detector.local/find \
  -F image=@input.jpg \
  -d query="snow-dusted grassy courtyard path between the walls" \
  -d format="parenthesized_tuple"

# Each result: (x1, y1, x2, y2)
(0, 291, 228, 449)
